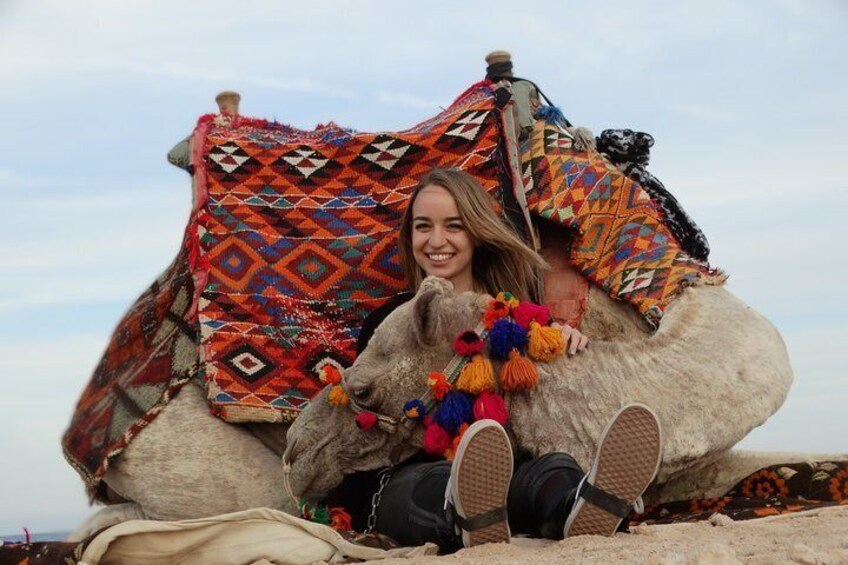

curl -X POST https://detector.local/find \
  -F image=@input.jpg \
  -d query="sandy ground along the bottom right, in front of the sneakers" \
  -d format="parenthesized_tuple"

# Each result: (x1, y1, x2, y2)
(370, 506, 848, 565)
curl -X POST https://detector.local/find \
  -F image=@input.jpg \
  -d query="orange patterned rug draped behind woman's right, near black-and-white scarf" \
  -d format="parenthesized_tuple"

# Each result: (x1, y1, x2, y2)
(521, 121, 725, 326)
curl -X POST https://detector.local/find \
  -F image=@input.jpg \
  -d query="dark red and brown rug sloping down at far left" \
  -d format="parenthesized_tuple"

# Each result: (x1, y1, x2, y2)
(62, 247, 198, 500)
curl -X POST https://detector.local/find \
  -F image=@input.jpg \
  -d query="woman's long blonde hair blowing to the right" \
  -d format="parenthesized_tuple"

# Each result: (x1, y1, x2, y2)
(398, 169, 548, 300)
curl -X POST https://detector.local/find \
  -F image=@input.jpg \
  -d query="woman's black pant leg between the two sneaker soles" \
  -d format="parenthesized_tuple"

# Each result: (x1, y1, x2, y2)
(507, 453, 584, 539)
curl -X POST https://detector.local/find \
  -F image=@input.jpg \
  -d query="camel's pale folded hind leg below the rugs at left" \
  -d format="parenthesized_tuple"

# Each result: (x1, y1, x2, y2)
(104, 383, 293, 520)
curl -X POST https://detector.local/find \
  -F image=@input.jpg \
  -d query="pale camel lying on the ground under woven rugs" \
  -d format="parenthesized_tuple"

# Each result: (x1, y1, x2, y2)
(72, 50, 804, 539)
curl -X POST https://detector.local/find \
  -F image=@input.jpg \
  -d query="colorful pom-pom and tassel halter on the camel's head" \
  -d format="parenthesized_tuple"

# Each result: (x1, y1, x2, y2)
(340, 292, 565, 458)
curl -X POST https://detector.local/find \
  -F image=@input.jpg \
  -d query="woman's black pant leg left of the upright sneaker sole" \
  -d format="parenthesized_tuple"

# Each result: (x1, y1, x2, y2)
(376, 461, 462, 553)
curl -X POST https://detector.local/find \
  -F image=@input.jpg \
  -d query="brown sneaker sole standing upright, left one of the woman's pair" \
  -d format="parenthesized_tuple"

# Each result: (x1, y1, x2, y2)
(451, 420, 513, 547)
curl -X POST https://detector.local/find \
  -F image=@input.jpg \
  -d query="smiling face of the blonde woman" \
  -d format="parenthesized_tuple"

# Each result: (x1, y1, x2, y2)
(412, 184, 474, 292)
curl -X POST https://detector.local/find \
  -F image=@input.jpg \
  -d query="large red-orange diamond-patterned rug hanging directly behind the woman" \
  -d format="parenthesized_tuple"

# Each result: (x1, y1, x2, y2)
(192, 82, 511, 422)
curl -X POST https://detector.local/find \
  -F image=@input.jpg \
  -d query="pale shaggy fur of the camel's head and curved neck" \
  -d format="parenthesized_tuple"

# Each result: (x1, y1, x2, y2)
(285, 278, 792, 498)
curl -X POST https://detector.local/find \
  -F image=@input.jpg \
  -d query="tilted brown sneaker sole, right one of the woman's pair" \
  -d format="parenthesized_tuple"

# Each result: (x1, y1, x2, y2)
(564, 404, 662, 538)
